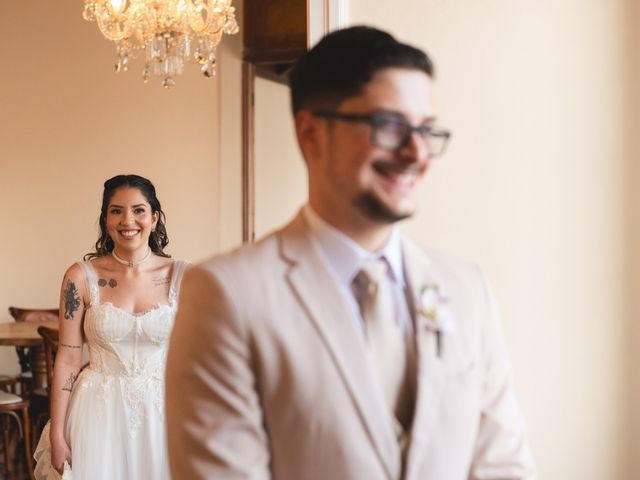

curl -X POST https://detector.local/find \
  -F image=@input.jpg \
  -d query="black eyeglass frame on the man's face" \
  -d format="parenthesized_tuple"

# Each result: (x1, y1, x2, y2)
(311, 110, 451, 157)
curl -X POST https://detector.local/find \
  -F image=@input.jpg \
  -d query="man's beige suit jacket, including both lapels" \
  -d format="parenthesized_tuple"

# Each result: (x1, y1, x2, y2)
(166, 214, 533, 480)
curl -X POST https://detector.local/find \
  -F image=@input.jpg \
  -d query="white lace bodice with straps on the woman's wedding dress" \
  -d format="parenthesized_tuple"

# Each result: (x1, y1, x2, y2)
(76, 261, 185, 436)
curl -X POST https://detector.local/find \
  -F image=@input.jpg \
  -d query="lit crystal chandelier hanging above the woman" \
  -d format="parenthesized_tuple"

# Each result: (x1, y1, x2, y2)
(82, 0, 238, 89)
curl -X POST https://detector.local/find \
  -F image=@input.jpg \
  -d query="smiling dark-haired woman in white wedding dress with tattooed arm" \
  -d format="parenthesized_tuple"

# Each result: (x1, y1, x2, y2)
(34, 175, 185, 480)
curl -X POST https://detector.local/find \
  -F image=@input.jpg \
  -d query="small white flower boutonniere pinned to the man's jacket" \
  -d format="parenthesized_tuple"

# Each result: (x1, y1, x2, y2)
(416, 284, 455, 357)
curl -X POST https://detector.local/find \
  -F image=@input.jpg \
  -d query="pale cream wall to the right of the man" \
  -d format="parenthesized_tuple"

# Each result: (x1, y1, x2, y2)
(349, 0, 639, 480)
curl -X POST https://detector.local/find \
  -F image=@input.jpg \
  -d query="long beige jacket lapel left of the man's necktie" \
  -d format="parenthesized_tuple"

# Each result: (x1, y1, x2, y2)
(279, 213, 401, 478)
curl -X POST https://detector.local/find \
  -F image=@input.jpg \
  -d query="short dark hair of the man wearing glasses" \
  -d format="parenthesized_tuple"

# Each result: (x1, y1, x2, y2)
(289, 26, 434, 114)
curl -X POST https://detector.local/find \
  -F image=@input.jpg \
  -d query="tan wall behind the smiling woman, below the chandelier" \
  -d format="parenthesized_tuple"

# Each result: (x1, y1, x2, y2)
(0, 2, 230, 372)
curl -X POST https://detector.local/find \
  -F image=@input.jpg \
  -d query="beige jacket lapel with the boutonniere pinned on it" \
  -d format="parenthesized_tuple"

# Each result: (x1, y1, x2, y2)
(402, 239, 445, 479)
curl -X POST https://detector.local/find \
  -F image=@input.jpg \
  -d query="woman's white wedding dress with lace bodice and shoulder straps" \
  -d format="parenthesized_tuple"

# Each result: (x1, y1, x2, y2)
(34, 261, 186, 480)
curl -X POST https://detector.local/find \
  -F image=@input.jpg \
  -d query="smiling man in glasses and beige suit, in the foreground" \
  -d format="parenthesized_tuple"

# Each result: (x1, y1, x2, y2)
(166, 27, 533, 480)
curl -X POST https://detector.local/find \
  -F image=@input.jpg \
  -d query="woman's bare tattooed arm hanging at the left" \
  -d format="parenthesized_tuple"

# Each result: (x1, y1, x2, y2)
(50, 264, 87, 472)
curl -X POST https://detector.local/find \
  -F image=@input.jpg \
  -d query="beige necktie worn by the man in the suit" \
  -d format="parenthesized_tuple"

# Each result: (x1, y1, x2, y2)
(353, 259, 409, 439)
